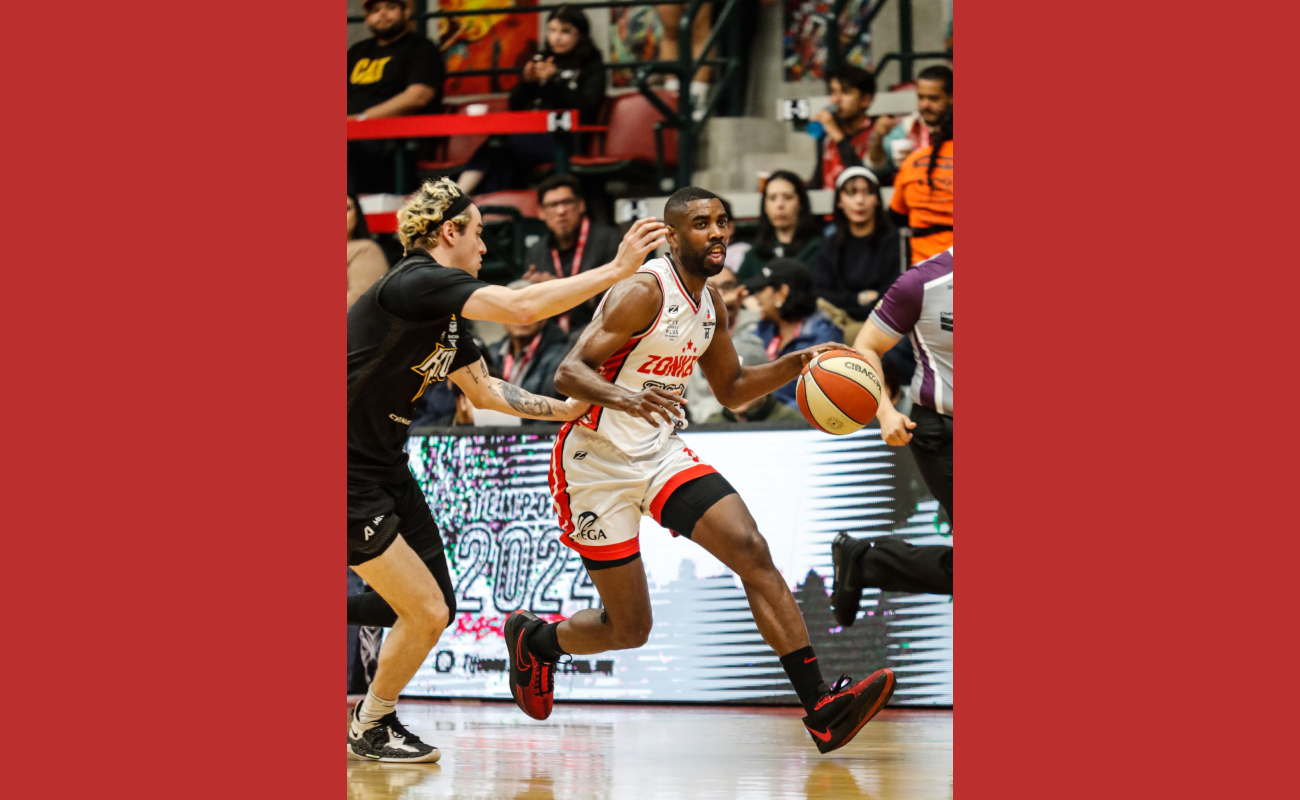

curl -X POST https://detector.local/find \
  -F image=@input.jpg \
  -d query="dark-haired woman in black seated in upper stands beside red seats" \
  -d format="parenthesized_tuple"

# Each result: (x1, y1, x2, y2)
(458, 4, 606, 194)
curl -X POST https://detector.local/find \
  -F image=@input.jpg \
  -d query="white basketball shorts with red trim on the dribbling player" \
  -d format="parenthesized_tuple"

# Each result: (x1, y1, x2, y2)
(550, 423, 716, 561)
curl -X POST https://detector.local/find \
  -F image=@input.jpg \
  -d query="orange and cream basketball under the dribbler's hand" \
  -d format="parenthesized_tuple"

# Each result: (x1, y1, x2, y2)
(796, 350, 881, 436)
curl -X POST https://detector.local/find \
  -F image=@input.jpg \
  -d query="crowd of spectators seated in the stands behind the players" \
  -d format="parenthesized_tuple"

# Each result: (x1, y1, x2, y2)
(347, 0, 953, 427)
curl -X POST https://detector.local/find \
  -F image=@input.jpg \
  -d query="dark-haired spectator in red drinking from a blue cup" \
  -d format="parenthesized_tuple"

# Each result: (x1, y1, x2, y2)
(809, 64, 893, 189)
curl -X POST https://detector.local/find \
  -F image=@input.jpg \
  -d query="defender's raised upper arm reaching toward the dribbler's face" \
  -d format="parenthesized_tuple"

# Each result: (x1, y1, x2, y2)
(462, 217, 666, 325)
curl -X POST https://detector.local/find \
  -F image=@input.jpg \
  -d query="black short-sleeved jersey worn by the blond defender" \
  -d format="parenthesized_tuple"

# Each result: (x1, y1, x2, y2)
(347, 250, 488, 484)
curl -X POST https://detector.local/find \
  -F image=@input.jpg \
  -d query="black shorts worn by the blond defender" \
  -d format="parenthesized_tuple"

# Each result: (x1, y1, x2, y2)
(347, 475, 445, 567)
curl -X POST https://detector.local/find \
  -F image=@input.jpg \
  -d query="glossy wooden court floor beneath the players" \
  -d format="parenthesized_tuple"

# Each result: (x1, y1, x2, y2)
(345, 701, 953, 800)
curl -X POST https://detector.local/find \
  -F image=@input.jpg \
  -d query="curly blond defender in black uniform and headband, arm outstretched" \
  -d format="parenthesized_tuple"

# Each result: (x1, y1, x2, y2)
(347, 178, 663, 761)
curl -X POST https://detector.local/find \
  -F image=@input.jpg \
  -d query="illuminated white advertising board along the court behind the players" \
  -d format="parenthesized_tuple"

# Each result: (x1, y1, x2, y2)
(404, 428, 953, 705)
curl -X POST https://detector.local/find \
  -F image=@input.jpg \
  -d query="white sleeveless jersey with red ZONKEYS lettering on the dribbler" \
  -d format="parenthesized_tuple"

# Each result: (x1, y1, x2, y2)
(577, 256, 718, 459)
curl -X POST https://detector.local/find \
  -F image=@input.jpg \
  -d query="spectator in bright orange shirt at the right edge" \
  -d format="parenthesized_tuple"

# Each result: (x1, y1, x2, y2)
(889, 96, 953, 264)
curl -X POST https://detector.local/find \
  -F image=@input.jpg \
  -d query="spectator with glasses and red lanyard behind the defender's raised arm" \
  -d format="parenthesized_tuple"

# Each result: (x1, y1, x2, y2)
(514, 174, 623, 331)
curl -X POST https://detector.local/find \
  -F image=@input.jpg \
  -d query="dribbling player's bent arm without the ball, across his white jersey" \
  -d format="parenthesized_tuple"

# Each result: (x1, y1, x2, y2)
(551, 273, 686, 425)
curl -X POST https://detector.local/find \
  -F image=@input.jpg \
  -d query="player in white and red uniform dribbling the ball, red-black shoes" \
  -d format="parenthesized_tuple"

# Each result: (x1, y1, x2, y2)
(504, 187, 894, 753)
